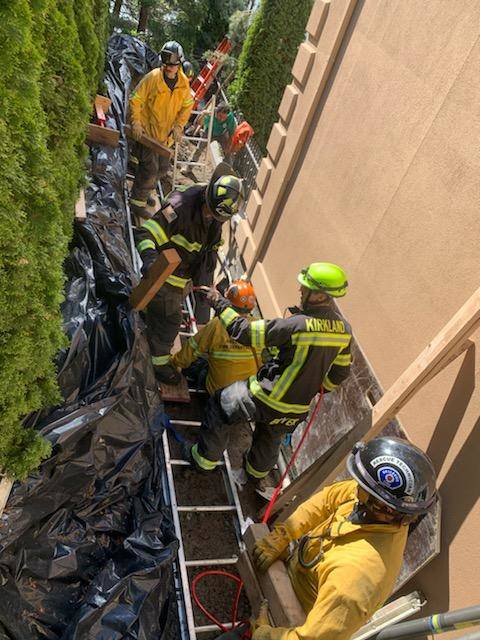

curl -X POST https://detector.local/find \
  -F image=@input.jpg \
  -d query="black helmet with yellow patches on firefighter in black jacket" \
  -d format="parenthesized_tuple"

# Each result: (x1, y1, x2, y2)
(205, 162, 244, 222)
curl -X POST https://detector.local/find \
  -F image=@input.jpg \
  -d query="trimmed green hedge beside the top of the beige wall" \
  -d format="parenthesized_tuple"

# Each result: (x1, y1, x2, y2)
(230, 0, 313, 151)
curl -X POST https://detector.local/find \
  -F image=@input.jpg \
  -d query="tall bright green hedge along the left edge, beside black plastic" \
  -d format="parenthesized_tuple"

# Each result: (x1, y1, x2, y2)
(0, 0, 108, 478)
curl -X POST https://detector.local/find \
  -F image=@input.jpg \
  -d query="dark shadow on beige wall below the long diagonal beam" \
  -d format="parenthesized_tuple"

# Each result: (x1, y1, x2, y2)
(398, 344, 480, 615)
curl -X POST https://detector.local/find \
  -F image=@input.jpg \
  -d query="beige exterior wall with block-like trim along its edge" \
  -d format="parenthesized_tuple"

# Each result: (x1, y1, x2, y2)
(238, 0, 480, 612)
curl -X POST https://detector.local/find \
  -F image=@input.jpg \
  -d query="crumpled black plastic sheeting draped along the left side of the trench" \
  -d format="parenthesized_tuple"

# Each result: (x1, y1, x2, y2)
(0, 36, 180, 640)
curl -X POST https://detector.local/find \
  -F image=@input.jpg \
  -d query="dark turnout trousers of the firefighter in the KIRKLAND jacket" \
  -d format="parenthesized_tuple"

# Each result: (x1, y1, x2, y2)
(192, 380, 305, 478)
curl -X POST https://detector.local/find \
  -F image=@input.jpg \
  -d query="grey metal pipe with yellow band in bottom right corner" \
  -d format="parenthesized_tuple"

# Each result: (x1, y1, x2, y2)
(374, 605, 480, 640)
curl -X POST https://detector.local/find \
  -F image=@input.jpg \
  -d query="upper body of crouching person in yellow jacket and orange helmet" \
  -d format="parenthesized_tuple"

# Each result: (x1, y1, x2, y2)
(170, 280, 261, 395)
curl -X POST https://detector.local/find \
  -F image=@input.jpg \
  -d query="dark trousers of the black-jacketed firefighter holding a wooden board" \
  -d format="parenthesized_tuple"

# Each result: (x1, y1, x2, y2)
(146, 284, 183, 367)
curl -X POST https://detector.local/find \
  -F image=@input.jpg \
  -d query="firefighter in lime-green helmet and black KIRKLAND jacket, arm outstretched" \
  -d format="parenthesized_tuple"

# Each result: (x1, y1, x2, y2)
(184, 262, 352, 490)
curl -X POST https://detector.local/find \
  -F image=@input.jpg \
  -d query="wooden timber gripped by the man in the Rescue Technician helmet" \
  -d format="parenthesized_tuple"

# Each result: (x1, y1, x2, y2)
(243, 523, 305, 627)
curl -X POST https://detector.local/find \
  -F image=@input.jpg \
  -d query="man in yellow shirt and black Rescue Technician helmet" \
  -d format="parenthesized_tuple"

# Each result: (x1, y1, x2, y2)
(253, 437, 436, 640)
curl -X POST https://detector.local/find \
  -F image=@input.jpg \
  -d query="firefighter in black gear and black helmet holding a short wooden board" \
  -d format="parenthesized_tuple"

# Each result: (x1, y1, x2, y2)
(135, 163, 243, 384)
